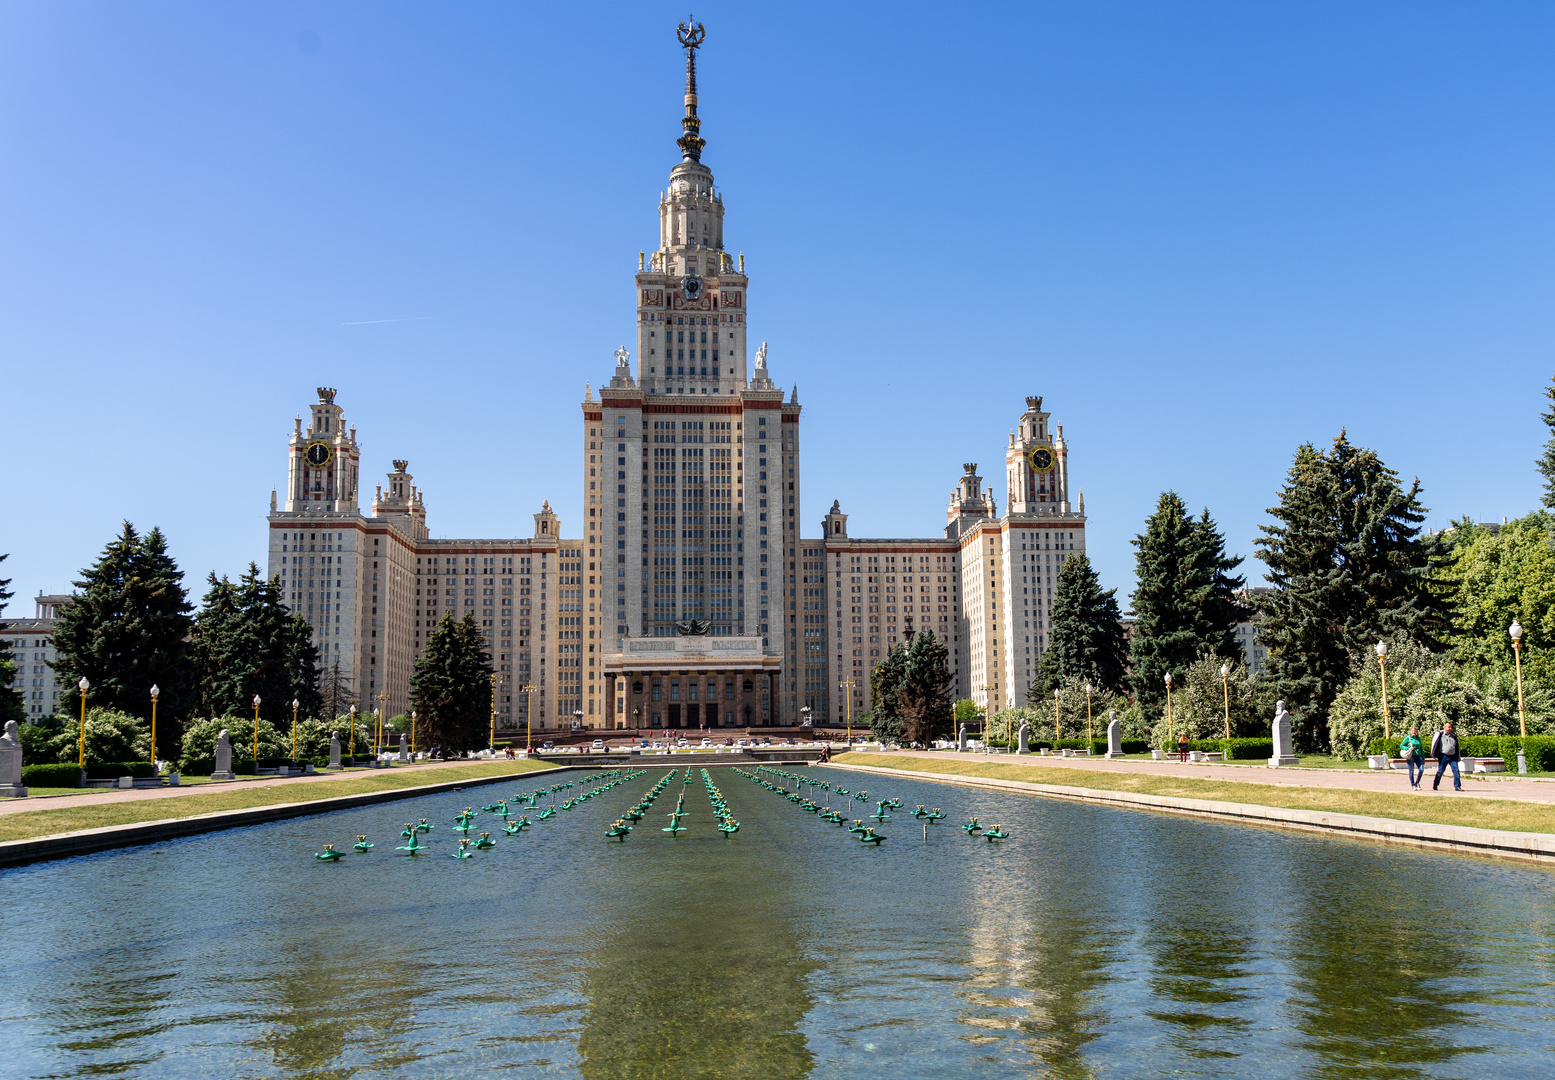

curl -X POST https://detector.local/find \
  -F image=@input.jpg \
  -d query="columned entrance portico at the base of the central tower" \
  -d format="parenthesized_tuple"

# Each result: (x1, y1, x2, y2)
(605, 637, 782, 730)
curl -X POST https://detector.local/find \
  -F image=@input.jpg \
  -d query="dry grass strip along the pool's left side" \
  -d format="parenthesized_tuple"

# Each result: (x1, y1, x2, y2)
(0, 760, 555, 841)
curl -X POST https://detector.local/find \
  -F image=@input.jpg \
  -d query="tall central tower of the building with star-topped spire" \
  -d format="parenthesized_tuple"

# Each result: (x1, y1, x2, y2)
(580, 23, 809, 727)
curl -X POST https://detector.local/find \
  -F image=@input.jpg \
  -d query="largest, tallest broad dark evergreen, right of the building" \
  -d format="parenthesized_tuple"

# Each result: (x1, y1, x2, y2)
(1256, 432, 1451, 747)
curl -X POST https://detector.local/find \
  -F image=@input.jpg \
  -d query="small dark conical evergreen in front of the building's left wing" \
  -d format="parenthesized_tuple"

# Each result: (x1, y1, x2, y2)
(411, 612, 491, 754)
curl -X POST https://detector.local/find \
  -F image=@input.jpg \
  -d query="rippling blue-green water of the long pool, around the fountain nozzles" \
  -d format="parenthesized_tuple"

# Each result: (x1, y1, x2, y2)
(0, 768, 1555, 1080)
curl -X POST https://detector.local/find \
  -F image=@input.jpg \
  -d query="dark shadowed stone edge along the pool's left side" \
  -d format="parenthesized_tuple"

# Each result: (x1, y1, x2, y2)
(0, 765, 581, 869)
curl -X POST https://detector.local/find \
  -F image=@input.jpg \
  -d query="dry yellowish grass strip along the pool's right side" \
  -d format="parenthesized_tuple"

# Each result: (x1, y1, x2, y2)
(833, 752, 1555, 833)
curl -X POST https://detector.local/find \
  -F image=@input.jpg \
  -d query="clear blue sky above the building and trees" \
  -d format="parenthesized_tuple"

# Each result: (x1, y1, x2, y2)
(0, 0, 1555, 615)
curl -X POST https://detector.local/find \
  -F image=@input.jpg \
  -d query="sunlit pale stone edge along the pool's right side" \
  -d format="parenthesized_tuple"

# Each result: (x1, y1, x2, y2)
(824, 761, 1555, 864)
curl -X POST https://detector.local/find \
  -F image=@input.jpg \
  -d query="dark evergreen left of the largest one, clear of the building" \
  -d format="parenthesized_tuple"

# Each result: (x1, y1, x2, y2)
(1129, 491, 1242, 718)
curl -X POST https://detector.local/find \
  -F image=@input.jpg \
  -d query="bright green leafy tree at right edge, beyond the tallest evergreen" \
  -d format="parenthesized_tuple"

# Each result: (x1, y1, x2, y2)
(1441, 510, 1555, 685)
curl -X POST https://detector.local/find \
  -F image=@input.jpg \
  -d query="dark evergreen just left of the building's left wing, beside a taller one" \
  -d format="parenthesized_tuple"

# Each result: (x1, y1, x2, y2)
(194, 563, 320, 730)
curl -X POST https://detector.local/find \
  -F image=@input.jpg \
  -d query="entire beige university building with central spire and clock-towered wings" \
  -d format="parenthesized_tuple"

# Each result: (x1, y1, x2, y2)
(269, 26, 1085, 729)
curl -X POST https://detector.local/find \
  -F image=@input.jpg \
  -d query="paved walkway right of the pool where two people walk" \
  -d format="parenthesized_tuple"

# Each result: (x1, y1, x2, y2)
(861, 751, 1555, 803)
